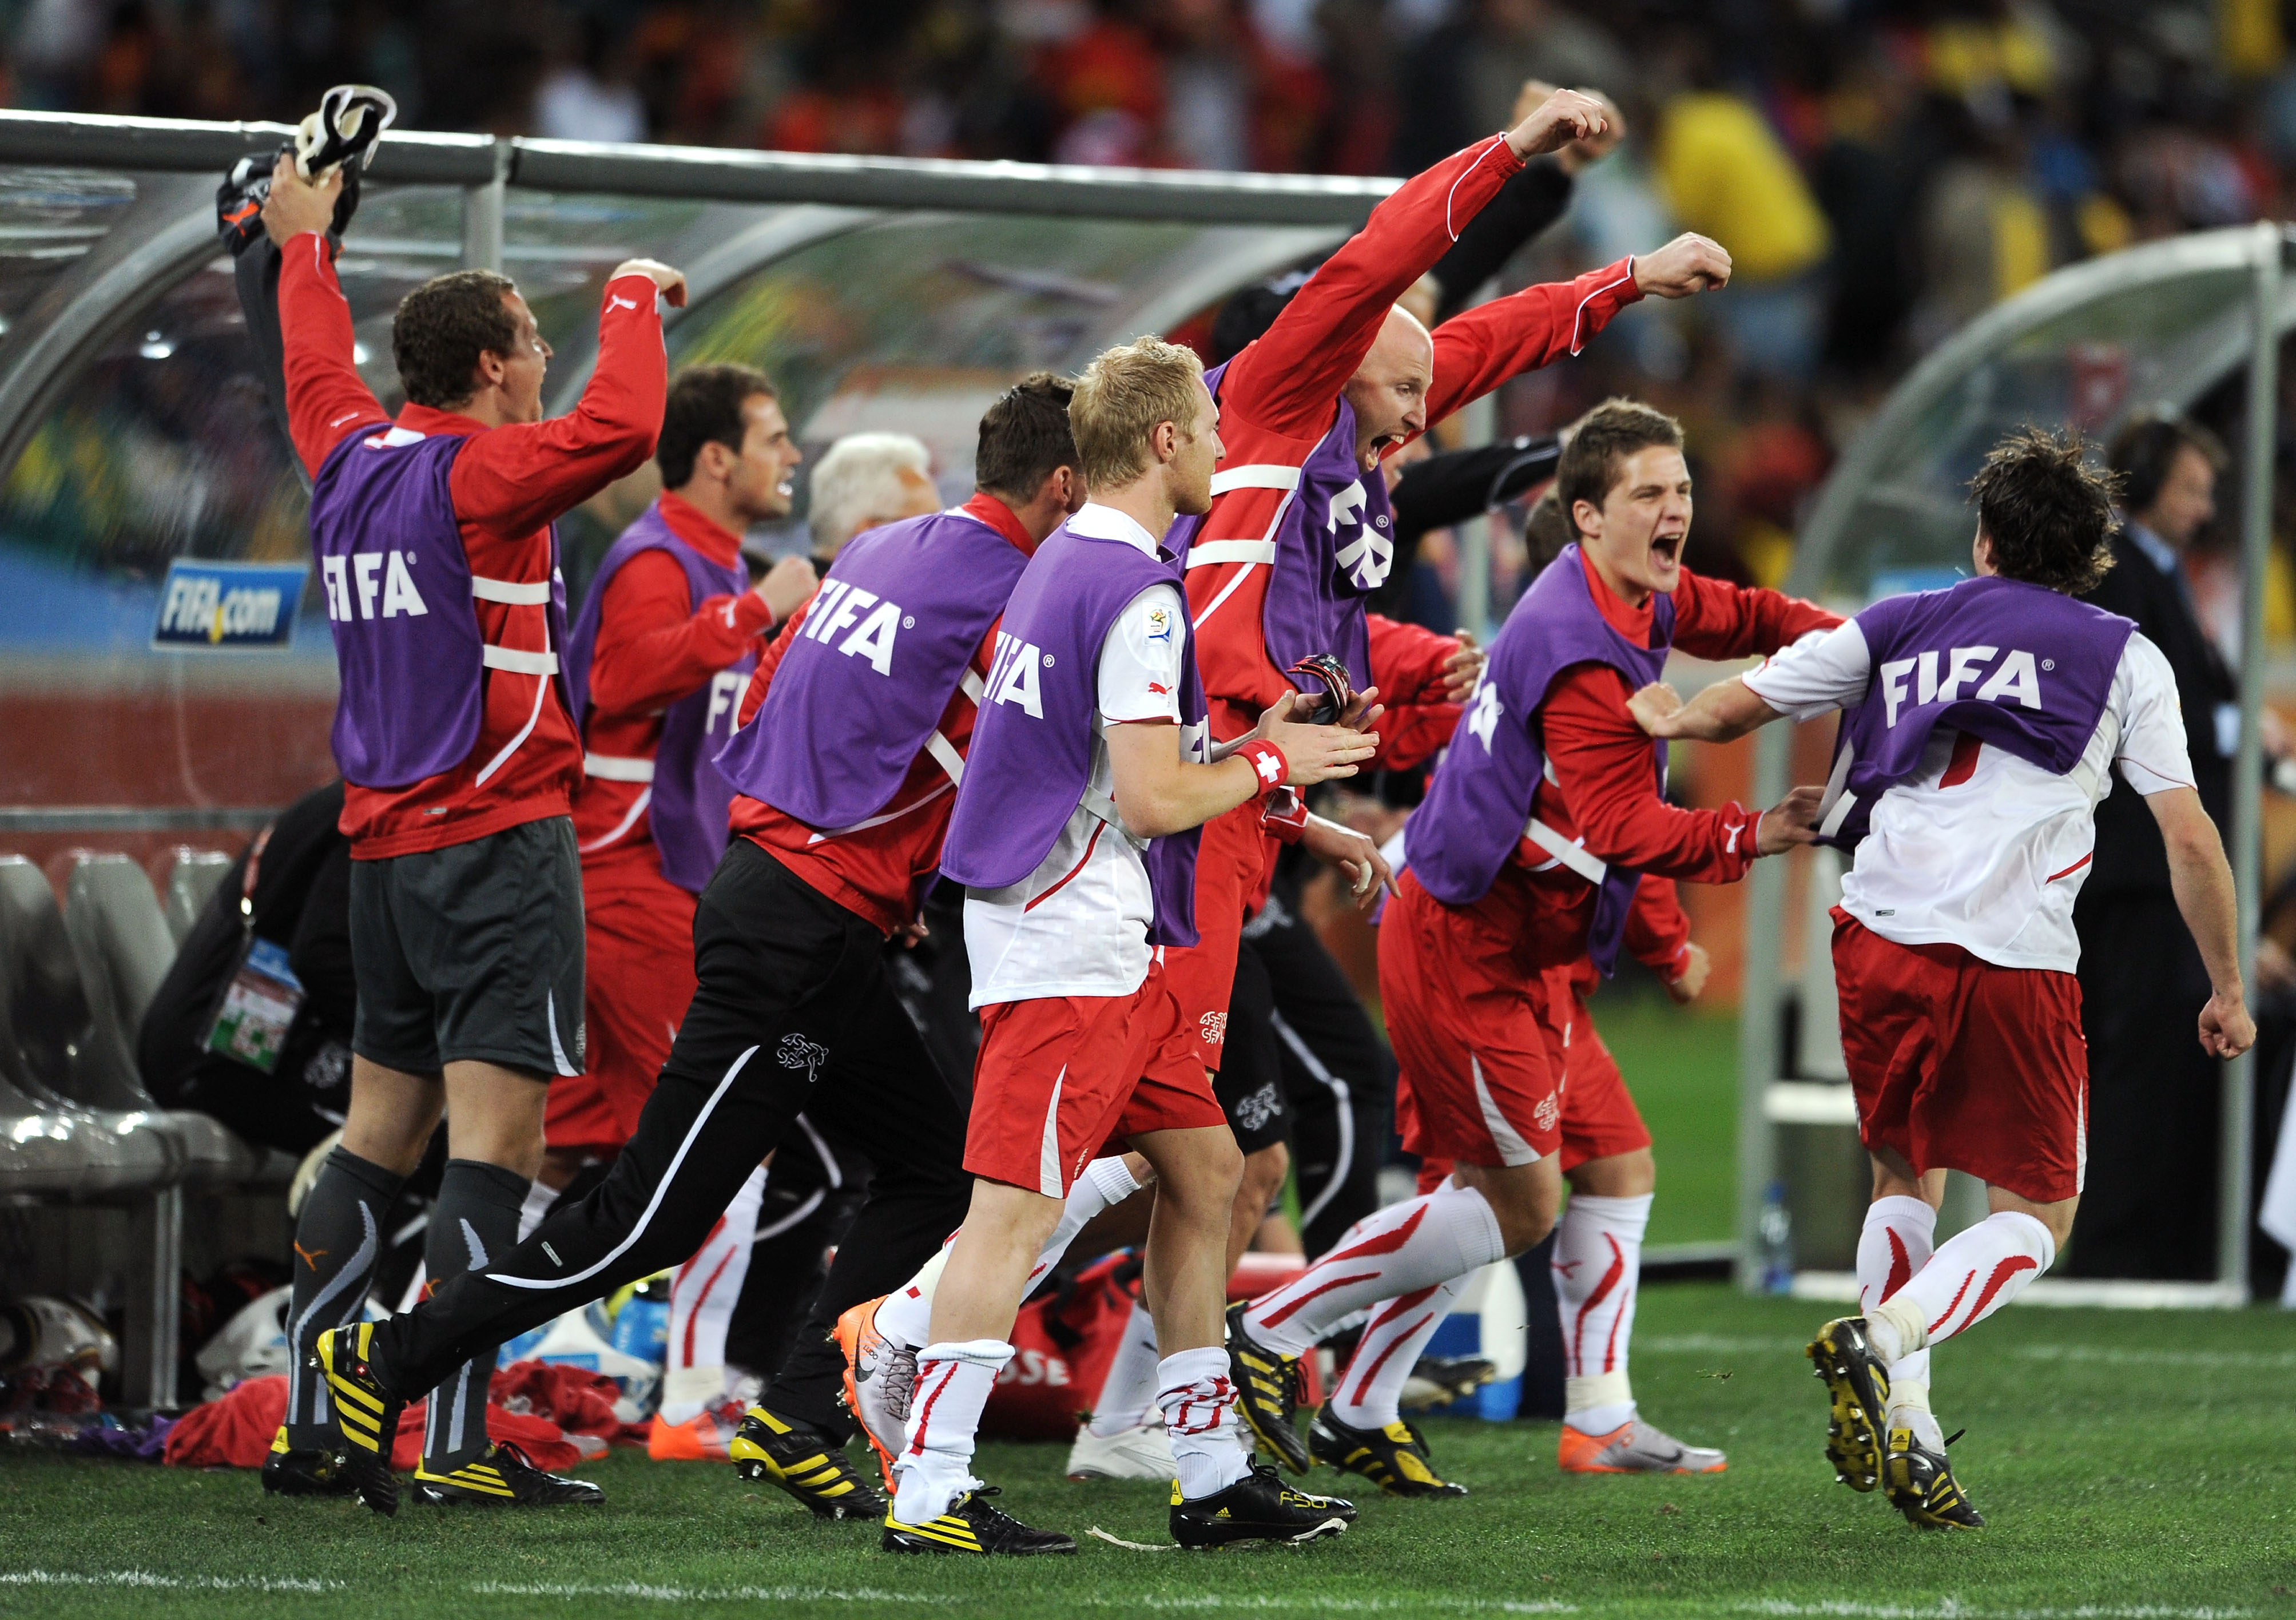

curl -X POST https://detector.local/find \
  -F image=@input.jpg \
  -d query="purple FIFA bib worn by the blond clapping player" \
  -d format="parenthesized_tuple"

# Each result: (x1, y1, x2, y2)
(942, 526, 1207, 946)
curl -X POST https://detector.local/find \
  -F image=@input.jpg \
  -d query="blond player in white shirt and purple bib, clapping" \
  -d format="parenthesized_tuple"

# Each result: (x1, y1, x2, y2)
(884, 338, 1377, 1554)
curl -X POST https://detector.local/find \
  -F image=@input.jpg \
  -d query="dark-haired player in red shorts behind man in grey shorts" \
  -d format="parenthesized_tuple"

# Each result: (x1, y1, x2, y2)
(555, 365, 815, 1457)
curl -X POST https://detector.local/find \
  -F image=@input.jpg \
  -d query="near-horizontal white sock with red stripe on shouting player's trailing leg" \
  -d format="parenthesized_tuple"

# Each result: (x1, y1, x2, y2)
(1245, 1182, 1506, 1356)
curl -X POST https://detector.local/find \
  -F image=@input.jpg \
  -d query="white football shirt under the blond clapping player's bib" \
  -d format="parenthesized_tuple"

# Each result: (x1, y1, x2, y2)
(964, 505, 1185, 1007)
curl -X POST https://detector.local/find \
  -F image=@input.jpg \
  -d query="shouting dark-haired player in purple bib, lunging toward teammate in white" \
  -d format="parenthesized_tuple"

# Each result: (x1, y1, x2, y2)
(1228, 399, 1837, 1494)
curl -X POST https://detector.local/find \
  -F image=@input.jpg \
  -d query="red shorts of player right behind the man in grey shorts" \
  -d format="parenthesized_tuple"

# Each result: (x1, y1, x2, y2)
(542, 863, 693, 1152)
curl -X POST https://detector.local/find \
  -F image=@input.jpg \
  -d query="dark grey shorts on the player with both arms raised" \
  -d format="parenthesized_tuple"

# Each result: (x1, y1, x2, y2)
(351, 815, 583, 1078)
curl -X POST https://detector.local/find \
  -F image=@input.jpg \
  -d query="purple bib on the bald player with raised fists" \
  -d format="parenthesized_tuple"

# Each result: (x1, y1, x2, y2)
(1164, 365, 1396, 725)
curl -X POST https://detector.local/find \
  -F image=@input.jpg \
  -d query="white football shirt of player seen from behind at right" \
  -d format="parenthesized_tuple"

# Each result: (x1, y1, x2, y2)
(1745, 620, 2192, 973)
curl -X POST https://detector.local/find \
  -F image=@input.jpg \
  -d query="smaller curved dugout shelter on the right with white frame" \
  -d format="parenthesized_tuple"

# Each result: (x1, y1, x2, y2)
(1738, 225, 2296, 1305)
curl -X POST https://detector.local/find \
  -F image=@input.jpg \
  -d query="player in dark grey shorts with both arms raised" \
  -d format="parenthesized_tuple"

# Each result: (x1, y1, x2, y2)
(262, 156, 684, 1503)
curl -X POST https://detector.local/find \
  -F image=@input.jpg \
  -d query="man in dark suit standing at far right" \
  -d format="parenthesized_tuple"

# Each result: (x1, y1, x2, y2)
(2062, 413, 2241, 1278)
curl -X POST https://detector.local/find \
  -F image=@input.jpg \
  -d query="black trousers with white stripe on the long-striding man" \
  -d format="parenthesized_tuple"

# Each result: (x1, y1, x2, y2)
(374, 837, 971, 1439)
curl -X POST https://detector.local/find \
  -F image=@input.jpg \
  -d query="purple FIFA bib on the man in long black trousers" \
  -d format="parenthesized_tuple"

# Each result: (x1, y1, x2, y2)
(716, 512, 1028, 831)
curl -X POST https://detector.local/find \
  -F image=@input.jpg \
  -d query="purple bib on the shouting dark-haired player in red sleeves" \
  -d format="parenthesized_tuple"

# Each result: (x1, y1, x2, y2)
(1408, 546, 1674, 975)
